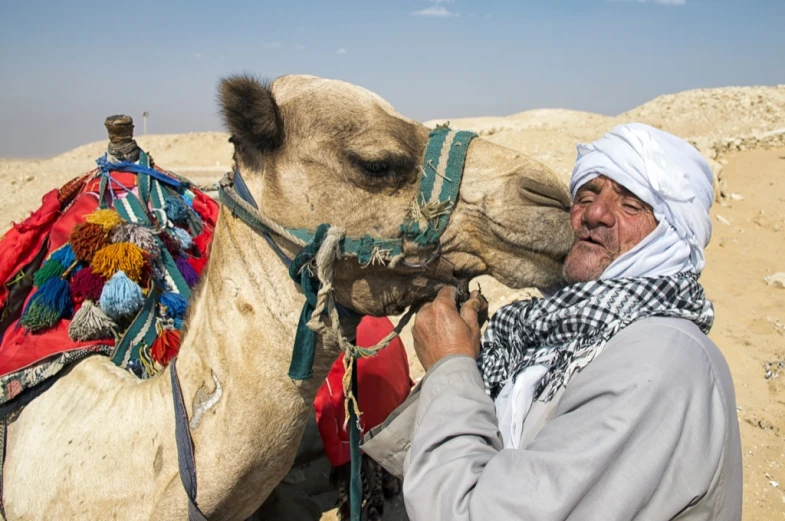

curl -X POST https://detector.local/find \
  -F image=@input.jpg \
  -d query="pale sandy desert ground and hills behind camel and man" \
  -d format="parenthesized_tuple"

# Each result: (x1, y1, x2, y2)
(0, 85, 785, 521)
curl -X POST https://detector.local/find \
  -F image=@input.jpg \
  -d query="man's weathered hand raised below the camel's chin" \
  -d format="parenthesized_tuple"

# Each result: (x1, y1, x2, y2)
(412, 286, 488, 371)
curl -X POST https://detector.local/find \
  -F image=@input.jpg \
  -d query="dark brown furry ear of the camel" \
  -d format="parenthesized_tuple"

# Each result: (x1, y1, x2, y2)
(220, 76, 283, 166)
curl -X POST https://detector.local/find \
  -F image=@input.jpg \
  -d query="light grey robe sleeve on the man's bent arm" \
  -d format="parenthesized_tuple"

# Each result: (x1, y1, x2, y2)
(403, 326, 727, 521)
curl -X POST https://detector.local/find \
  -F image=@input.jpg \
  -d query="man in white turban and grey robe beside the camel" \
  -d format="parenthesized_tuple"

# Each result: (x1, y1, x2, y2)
(364, 124, 742, 521)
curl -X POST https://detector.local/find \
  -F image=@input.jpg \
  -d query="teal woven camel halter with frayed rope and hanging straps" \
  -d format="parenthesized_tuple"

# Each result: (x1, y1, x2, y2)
(170, 126, 477, 521)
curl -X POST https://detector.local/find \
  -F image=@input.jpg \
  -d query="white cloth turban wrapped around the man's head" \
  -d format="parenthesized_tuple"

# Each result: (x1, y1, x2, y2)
(570, 123, 714, 279)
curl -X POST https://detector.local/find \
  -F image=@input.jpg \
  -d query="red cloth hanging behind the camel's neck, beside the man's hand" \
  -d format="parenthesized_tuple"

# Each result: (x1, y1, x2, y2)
(314, 317, 414, 467)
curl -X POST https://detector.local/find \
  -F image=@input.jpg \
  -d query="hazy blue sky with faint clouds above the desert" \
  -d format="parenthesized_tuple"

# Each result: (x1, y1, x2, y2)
(0, 0, 785, 157)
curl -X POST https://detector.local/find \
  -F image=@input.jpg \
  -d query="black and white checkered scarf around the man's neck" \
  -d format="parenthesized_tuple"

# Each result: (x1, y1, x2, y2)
(477, 272, 714, 402)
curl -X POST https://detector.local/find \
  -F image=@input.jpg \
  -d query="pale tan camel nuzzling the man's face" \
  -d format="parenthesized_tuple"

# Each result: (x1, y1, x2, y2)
(3, 75, 572, 520)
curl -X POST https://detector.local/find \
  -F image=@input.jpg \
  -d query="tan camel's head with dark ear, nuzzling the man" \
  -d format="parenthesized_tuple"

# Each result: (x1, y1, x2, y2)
(220, 76, 573, 315)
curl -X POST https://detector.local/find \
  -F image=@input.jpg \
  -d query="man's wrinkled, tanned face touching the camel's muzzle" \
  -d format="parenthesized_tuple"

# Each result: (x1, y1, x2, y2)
(564, 176, 657, 283)
